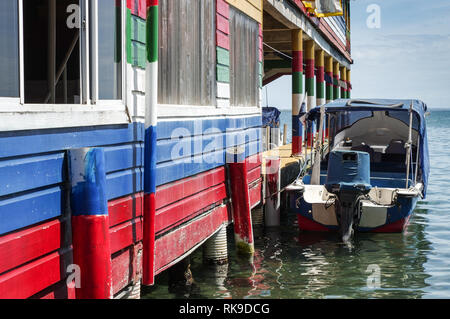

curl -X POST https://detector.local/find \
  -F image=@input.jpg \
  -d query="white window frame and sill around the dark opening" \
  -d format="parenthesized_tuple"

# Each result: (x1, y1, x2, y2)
(0, 0, 131, 132)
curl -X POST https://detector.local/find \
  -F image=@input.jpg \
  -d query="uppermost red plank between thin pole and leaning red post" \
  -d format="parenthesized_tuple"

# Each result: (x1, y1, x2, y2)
(156, 167, 225, 210)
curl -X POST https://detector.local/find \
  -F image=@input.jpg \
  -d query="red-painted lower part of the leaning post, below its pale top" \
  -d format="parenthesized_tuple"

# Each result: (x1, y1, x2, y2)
(228, 161, 253, 244)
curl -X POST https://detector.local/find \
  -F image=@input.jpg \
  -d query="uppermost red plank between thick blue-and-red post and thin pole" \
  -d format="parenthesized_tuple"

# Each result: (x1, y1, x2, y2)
(108, 193, 144, 227)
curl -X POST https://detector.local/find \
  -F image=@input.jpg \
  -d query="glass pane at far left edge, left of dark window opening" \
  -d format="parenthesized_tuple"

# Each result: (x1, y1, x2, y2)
(0, 0, 19, 97)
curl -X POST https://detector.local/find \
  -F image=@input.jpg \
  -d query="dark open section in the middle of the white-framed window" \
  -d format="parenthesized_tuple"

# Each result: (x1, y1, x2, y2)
(23, 0, 81, 104)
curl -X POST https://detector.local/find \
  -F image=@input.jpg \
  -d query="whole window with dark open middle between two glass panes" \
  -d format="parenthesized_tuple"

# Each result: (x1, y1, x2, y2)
(0, 0, 125, 104)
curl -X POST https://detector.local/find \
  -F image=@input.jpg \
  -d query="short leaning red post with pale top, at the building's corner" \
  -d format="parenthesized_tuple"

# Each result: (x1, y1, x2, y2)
(226, 146, 255, 255)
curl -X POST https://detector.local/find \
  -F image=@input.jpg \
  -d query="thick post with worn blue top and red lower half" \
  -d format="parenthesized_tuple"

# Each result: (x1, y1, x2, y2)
(68, 148, 112, 299)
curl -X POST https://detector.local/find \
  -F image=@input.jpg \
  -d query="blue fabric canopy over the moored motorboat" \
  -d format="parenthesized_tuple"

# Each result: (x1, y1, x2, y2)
(307, 99, 430, 196)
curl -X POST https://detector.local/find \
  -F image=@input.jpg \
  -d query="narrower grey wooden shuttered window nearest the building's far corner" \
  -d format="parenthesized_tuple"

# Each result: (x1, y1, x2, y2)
(230, 7, 259, 106)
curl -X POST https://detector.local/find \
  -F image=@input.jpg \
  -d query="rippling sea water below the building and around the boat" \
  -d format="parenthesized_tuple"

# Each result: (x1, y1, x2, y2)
(144, 110, 450, 299)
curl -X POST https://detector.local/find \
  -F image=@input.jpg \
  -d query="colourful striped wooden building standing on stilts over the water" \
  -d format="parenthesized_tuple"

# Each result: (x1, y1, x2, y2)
(0, 0, 352, 298)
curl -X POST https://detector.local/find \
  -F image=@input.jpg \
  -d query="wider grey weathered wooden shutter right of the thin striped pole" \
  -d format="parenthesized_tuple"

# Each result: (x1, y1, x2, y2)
(158, 0, 216, 105)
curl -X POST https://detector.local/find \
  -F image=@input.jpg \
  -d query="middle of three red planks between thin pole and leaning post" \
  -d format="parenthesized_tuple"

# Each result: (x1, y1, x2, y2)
(155, 184, 227, 234)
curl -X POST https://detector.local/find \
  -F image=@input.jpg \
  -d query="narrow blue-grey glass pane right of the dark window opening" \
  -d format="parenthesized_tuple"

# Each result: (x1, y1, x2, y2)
(98, 0, 122, 100)
